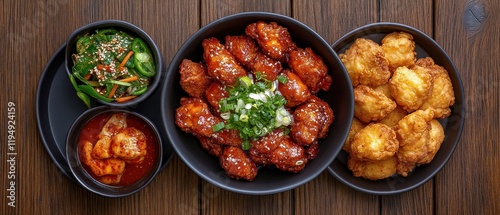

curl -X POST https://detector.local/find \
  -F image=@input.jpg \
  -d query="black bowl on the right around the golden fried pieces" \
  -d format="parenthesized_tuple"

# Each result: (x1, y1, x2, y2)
(328, 22, 465, 195)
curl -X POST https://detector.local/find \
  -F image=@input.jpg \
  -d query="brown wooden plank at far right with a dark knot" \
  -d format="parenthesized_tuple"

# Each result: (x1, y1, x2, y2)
(435, 0, 500, 214)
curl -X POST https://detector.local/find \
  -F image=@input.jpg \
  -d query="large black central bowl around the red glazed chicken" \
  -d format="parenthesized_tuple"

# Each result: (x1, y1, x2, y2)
(162, 12, 354, 195)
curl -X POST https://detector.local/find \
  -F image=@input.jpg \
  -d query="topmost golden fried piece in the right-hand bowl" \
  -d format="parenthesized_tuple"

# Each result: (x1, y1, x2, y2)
(381, 32, 417, 71)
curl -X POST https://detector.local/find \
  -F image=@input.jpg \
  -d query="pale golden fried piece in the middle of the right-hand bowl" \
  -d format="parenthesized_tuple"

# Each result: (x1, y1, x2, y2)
(389, 66, 433, 112)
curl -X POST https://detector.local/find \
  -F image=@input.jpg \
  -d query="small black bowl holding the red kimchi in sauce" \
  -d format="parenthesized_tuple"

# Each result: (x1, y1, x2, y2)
(66, 106, 163, 197)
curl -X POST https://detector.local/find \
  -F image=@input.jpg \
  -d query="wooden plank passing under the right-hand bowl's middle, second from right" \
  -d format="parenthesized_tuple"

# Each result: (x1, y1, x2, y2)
(380, 0, 434, 214)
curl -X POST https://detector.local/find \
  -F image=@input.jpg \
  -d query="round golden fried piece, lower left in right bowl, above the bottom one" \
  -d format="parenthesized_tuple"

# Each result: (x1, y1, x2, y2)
(350, 123, 399, 161)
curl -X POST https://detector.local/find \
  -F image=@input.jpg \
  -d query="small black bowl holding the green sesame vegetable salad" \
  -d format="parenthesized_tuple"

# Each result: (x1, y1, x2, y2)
(65, 20, 163, 108)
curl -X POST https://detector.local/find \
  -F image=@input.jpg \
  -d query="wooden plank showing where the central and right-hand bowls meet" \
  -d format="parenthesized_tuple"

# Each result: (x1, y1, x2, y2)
(293, 0, 380, 214)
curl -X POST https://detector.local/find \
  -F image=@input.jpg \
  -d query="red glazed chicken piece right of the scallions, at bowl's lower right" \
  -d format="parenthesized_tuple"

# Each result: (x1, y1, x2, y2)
(290, 96, 334, 146)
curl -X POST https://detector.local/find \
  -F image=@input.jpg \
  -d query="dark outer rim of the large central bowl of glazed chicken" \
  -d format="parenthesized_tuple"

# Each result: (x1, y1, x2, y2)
(162, 12, 354, 195)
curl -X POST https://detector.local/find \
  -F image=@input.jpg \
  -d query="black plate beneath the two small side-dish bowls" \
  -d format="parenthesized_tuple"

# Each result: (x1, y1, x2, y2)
(36, 45, 174, 180)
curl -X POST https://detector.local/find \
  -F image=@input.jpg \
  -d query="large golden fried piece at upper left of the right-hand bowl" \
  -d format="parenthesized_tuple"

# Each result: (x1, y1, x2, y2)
(339, 38, 391, 87)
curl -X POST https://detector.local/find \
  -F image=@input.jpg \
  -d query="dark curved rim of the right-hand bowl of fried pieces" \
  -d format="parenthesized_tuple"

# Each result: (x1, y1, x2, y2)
(327, 22, 466, 195)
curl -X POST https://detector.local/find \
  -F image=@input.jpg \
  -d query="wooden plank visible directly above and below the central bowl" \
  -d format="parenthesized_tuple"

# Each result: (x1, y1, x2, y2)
(201, 0, 293, 215)
